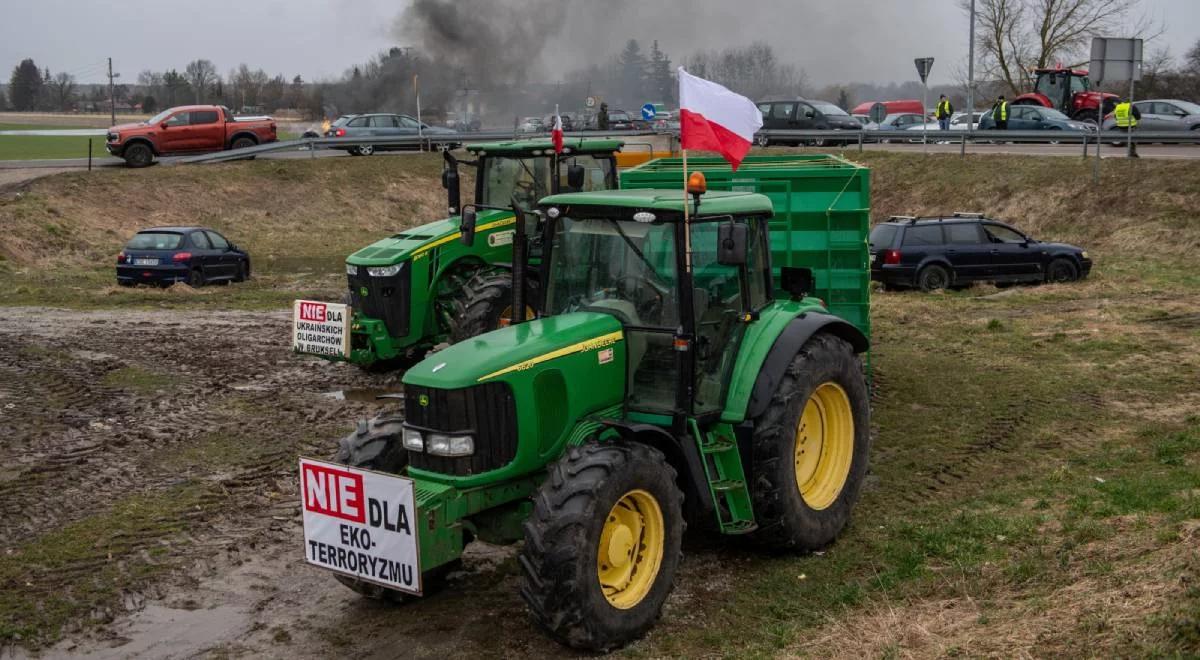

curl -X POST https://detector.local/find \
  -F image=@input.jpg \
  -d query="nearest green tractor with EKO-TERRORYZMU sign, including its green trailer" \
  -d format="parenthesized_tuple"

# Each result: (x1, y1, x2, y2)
(301, 156, 870, 650)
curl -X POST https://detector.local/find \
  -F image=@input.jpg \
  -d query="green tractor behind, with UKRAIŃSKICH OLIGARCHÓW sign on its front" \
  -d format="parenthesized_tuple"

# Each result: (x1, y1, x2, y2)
(293, 139, 623, 368)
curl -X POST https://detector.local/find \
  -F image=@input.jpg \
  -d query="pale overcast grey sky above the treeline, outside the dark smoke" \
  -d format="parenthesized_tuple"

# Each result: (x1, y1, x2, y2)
(0, 0, 1200, 84)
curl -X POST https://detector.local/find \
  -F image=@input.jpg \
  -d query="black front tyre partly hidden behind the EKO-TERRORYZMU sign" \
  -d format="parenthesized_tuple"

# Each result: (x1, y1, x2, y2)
(334, 410, 461, 604)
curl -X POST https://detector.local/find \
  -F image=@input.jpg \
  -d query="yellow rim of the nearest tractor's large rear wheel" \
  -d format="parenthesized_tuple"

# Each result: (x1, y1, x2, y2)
(796, 383, 854, 510)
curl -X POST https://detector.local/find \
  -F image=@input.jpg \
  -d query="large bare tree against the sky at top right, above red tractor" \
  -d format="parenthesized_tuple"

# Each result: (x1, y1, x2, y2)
(959, 0, 1147, 95)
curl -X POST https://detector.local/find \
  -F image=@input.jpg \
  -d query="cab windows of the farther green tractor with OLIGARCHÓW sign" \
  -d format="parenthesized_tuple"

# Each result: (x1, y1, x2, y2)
(479, 154, 616, 209)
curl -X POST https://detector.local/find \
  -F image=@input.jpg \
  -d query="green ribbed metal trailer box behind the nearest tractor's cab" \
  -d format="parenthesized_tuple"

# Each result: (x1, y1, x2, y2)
(620, 154, 871, 337)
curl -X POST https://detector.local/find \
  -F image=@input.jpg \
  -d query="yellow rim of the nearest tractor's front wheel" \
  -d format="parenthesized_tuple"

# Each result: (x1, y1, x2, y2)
(596, 490, 665, 610)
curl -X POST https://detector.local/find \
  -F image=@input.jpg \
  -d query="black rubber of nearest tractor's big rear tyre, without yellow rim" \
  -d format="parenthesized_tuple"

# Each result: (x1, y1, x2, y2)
(750, 332, 871, 552)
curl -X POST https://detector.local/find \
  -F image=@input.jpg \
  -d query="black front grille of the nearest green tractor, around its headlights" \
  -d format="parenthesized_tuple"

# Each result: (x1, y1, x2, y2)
(404, 383, 517, 476)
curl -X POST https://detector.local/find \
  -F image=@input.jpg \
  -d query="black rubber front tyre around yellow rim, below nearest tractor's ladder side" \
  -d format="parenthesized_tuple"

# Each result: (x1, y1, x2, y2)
(520, 443, 685, 652)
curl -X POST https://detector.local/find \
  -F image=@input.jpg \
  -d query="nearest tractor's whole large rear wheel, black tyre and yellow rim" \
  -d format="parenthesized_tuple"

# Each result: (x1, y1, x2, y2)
(751, 332, 870, 551)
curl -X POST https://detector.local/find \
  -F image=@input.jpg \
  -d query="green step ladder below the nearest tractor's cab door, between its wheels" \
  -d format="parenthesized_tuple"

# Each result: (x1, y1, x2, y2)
(689, 420, 758, 534)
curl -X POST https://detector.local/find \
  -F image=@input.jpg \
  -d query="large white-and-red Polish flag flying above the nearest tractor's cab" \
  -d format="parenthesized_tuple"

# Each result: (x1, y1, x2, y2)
(679, 66, 762, 172)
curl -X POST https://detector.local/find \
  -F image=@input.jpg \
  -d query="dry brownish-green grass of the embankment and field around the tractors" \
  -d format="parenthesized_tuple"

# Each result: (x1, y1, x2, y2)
(0, 148, 1200, 658)
